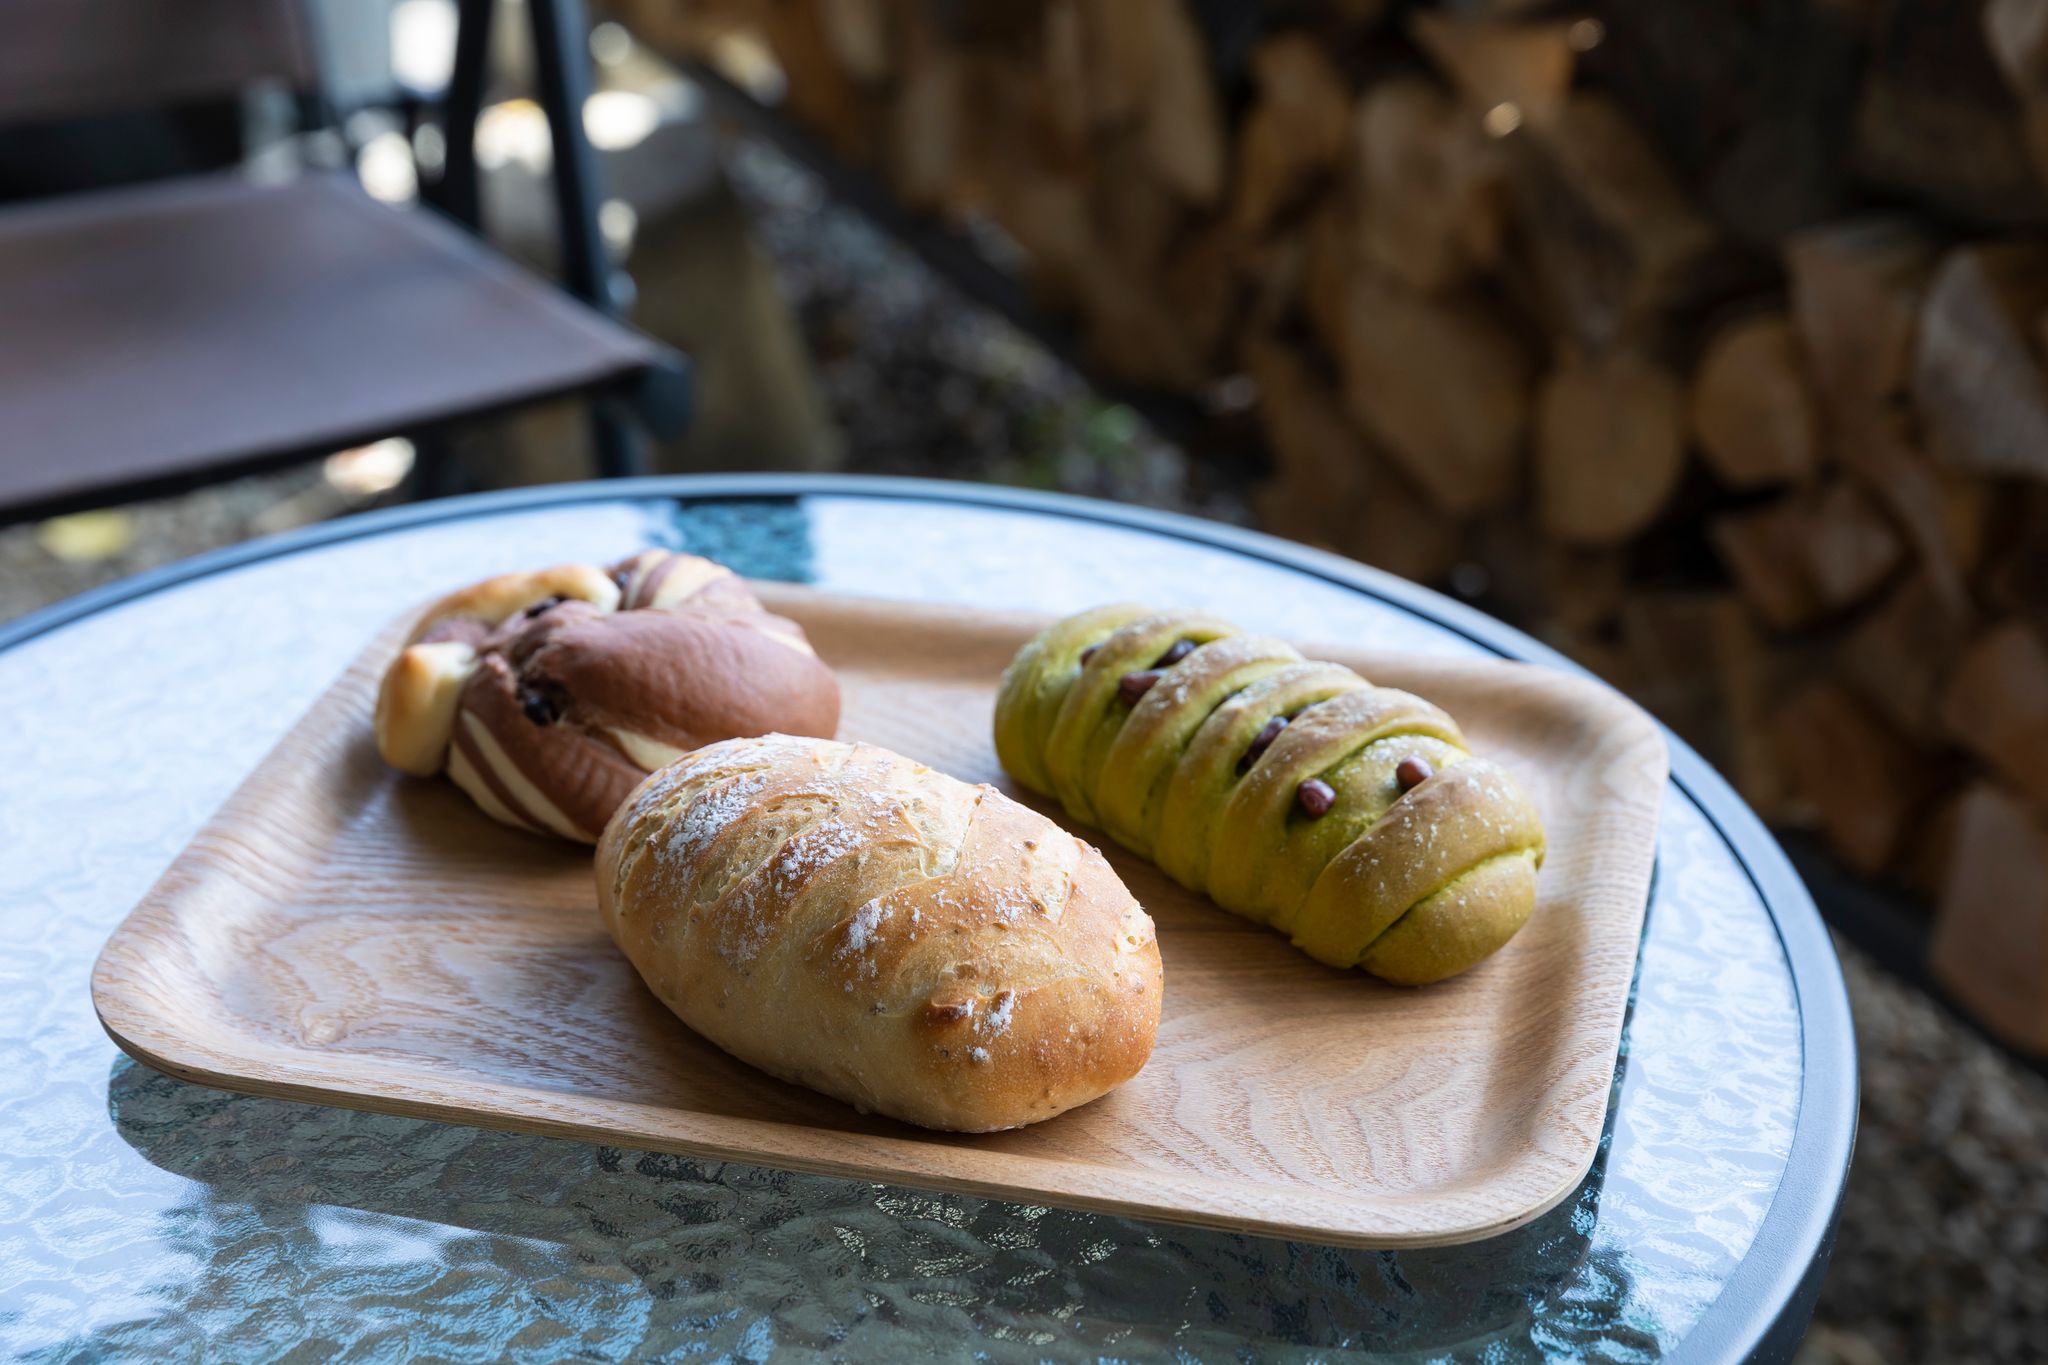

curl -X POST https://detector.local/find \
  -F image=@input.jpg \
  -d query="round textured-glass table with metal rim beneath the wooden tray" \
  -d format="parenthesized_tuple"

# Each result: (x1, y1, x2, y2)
(0, 475, 1855, 1361)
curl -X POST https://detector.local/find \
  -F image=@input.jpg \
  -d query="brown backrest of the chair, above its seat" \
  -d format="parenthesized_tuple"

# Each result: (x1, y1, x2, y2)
(0, 0, 317, 125)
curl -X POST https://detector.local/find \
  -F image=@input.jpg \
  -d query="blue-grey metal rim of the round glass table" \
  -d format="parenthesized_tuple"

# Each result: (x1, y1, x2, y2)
(0, 473, 1858, 1363)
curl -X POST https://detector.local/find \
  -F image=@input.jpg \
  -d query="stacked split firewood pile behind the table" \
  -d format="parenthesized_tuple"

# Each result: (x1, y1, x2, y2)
(612, 0, 2048, 1050)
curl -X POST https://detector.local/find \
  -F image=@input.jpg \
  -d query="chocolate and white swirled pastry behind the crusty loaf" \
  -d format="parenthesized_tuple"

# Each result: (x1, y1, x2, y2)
(377, 551, 840, 843)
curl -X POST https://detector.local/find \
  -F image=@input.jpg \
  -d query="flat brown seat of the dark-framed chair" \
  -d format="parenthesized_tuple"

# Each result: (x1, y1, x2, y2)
(0, 172, 662, 516)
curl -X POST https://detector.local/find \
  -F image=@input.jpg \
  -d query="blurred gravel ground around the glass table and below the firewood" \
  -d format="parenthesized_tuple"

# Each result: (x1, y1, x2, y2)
(0, 130, 2048, 1365)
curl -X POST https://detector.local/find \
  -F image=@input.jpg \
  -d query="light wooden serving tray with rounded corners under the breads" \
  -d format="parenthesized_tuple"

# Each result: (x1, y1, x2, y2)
(92, 583, 1665, 1246)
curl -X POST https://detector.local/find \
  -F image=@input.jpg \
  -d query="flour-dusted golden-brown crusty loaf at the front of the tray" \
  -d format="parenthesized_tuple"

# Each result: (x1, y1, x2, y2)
(598, 735, 1161, 1132)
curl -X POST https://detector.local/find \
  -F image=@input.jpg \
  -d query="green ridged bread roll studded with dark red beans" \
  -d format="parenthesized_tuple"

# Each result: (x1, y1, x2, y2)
(995, 604, 1544, 984)
